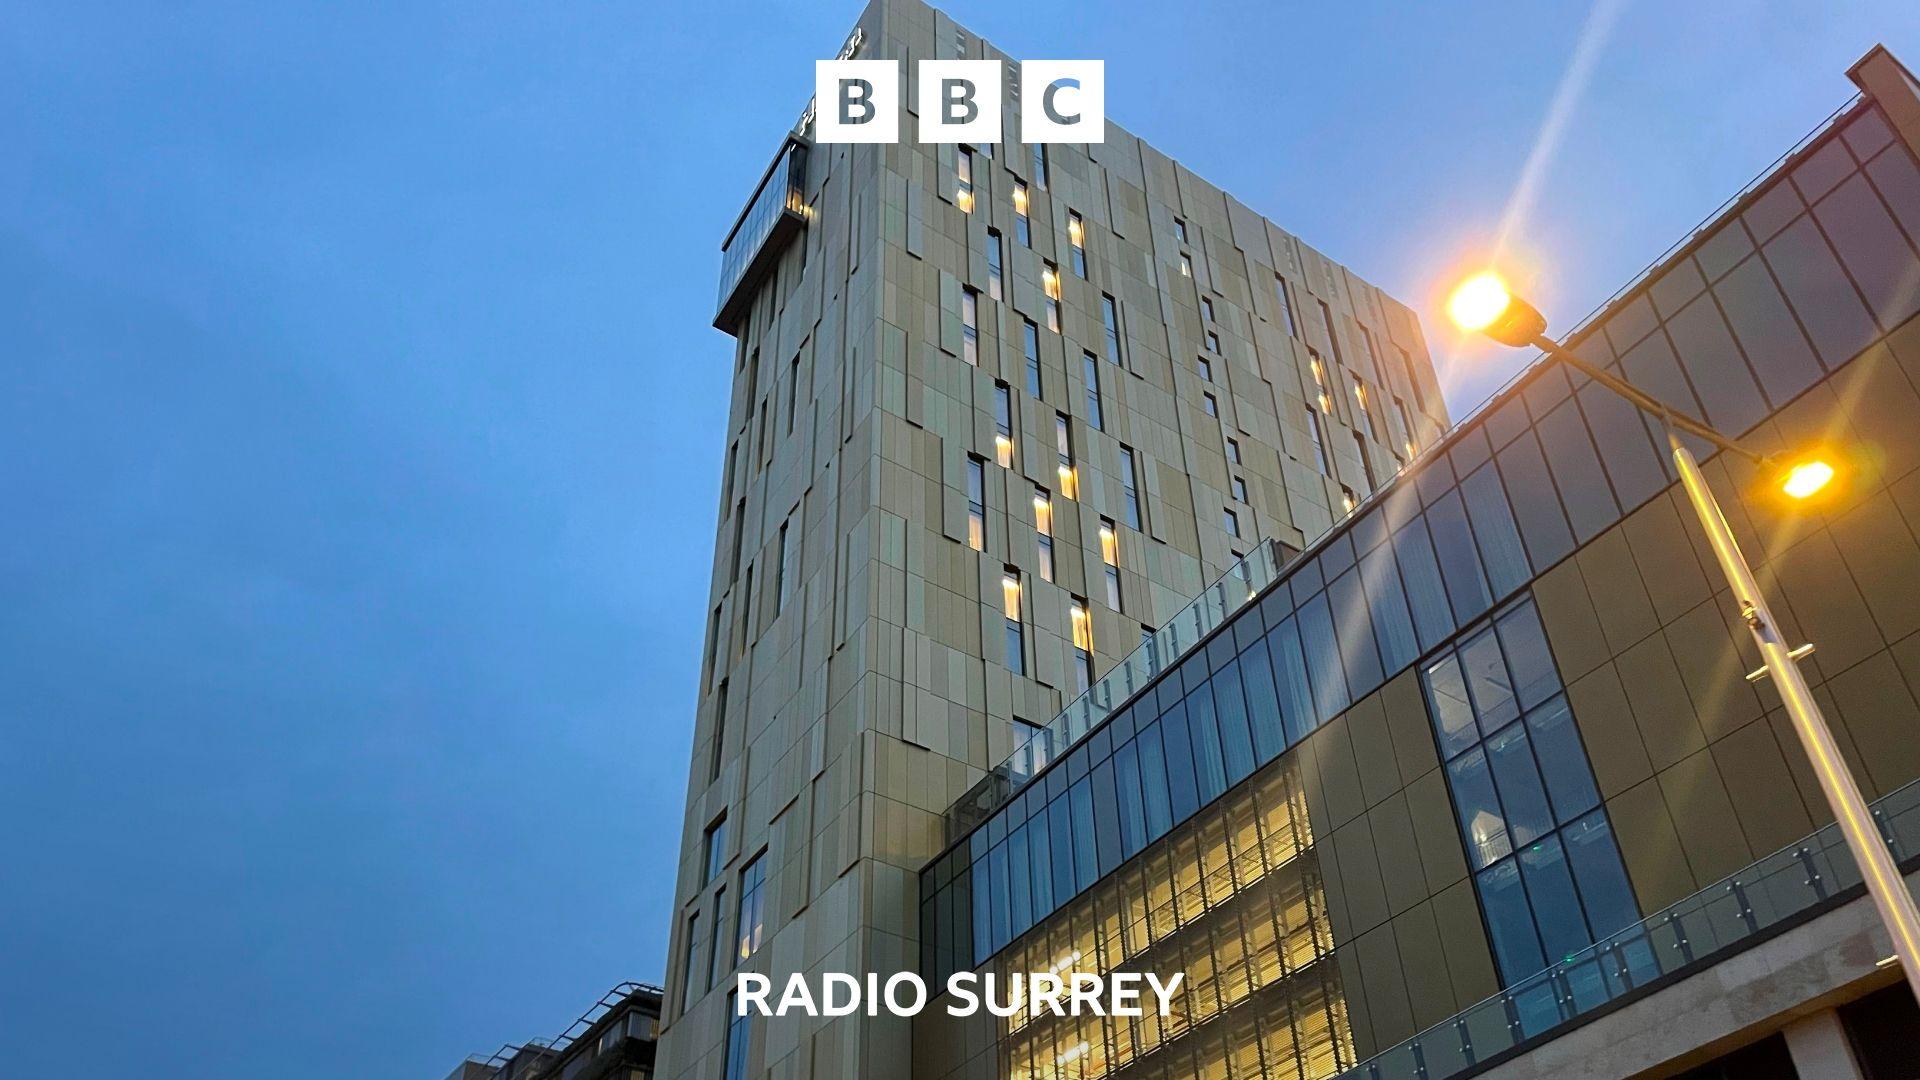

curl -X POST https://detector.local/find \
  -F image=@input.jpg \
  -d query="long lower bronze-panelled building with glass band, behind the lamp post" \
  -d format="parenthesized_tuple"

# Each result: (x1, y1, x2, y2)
(910, 48, 1920, 1080)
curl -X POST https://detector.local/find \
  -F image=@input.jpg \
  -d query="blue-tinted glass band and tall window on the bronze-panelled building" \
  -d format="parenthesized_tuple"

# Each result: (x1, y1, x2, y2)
(922, 94, 1920, 1006)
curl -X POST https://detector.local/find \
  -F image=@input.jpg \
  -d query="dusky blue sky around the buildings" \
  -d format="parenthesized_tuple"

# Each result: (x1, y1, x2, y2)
(0, 0, 1920, 1080)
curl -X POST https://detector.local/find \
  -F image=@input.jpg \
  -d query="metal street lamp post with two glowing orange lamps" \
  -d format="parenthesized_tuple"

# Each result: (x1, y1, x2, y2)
(1448, 273, 1920, 999)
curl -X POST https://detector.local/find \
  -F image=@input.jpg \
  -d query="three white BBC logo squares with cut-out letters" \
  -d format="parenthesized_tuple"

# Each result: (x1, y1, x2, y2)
(812, 60, 1106, 146)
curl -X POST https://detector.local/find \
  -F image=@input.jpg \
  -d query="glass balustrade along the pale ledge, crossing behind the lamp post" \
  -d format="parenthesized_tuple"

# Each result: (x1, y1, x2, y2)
(1340, 780, 1920, 1080)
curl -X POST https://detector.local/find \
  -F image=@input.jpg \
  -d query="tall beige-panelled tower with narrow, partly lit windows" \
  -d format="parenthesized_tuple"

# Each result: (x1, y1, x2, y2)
(660, 0, 1446, 1080)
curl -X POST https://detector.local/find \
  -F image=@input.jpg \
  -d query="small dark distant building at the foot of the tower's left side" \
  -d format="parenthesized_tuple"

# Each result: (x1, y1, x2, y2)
(447, 982, 662, 1080)
